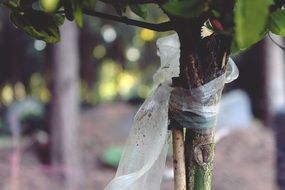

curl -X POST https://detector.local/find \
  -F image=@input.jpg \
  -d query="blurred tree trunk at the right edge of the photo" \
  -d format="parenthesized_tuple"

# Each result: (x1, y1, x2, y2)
(266, 34, 285, 190)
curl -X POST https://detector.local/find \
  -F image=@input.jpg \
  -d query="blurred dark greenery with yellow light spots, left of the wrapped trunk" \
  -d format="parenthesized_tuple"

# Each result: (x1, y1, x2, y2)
(0, 4, 173, 135)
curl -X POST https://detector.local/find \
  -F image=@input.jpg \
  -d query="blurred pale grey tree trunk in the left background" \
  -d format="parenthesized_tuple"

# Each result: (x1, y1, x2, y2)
(51, 22, 82, 190)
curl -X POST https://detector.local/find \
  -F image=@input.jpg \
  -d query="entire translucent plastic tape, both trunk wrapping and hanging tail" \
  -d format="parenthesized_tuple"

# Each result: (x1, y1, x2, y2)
(105, 34, 238, 190)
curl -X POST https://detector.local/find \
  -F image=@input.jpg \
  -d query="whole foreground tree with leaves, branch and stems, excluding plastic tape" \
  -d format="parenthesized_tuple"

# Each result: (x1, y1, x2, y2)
(3, 0, 285, 190)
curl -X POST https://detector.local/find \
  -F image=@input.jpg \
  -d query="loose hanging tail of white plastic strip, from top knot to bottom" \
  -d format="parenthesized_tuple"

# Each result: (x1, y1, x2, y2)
(105, 34, 235, 190)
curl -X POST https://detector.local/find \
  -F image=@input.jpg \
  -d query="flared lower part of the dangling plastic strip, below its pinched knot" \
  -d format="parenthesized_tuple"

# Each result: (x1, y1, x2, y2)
(105, 85, 171, 190)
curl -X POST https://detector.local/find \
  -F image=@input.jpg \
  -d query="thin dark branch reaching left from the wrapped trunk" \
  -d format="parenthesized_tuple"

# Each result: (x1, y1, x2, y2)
(83, 9, 173, 32)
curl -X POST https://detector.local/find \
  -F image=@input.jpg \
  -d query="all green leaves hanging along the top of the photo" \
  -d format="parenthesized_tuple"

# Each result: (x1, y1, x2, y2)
(2, 0, 285, 52)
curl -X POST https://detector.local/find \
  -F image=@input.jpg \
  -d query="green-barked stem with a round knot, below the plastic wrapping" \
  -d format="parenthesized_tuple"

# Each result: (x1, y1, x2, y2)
(185, 128, 215, 190)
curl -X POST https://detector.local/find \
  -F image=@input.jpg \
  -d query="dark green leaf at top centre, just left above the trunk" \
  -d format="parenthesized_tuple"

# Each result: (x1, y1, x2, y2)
(162, 0, 209, 18)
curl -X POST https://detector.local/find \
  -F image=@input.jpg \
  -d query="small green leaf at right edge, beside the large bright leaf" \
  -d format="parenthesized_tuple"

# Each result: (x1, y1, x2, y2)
(268, 10, 285, 36)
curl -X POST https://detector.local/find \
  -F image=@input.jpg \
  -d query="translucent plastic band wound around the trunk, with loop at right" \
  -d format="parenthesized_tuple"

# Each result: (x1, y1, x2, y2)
(169, 58, 239, 129)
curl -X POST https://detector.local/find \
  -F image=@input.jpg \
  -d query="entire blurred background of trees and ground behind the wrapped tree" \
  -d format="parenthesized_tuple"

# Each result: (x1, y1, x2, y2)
(0, 2, 285, 190)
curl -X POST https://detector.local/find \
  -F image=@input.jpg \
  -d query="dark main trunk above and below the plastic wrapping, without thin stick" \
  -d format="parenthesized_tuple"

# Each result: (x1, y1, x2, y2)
(168, 18, 231, 190)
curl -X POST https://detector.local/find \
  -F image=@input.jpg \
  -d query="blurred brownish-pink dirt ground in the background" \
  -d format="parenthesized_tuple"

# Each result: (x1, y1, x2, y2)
(0, 103, 275, 190)
